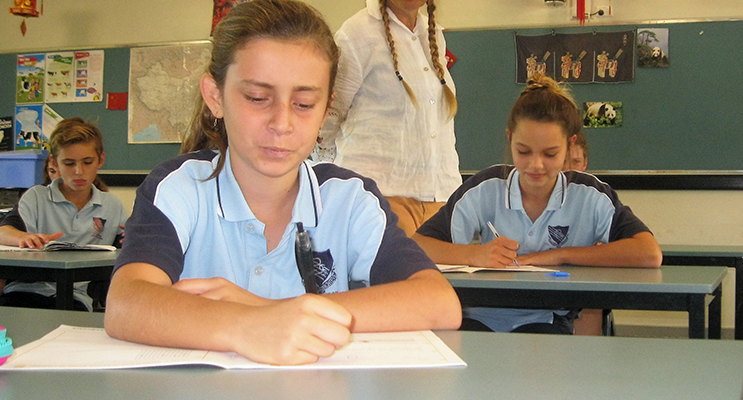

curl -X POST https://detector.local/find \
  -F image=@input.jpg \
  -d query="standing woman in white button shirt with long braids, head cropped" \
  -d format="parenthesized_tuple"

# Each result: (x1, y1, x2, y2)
(313, 0, 462, 236)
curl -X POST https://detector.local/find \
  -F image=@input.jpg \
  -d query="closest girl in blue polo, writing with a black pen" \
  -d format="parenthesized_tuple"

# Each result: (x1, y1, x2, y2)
(105, 0, 461, 364)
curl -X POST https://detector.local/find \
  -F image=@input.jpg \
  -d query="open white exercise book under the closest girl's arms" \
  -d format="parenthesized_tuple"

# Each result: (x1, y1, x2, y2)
(0, 325, 467, 370)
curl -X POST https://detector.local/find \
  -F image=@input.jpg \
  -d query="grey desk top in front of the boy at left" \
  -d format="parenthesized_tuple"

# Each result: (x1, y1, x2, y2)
(0, 250, 119, 269)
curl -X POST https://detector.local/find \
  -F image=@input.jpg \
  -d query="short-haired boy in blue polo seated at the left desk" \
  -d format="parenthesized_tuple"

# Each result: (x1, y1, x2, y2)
(0, 117, 127, 311)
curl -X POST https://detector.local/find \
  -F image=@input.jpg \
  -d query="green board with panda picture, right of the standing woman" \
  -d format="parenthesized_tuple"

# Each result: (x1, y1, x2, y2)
(446, 21, 743, 171)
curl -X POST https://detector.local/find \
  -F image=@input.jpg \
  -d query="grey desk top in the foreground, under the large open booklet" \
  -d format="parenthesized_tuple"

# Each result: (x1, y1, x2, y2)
(0, 307, 743, 400)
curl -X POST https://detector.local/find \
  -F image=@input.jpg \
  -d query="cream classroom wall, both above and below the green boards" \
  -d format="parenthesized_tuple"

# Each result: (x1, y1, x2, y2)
(0, 0, 743, 328)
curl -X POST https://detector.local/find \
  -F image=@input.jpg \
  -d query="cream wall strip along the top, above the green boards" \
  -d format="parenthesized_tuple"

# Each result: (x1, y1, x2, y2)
(0, 0, 743, 53)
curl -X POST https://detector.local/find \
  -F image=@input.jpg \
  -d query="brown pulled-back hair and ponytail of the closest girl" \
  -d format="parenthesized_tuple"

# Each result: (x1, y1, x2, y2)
(181, 0, 340, 179)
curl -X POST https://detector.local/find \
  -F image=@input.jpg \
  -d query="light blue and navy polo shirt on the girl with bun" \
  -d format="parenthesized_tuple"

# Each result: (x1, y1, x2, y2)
(418, 165, 649, 332)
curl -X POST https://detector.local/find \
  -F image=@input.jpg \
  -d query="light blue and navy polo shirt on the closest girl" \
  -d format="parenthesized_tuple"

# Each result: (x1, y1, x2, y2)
(114, 150, 436, 299)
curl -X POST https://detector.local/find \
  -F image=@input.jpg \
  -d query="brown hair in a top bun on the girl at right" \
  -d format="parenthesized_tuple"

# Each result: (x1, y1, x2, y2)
(508, 74, 583, 138)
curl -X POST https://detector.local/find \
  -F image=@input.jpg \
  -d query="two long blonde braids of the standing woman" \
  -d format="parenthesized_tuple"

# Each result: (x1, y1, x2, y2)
(379, 0, 457, 119)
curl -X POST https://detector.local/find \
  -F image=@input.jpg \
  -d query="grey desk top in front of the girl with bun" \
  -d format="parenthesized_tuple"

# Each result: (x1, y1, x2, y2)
(444, 266, 727, 294)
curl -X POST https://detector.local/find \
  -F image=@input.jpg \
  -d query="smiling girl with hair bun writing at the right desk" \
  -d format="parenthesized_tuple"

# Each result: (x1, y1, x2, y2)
(413, 76, 662, 334)
